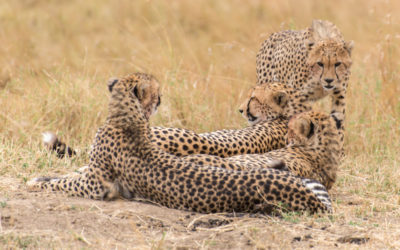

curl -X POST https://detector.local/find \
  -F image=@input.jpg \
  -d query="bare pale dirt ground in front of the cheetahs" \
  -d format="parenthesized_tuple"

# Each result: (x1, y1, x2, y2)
(0, 177, 400, 249)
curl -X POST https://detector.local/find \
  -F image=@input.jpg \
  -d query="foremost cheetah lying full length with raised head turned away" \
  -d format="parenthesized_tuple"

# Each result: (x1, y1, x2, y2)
(27, 72, 331, 213)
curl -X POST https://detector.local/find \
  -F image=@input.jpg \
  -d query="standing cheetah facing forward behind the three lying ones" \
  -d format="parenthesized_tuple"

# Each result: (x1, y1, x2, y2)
(256, 20, 353, 151)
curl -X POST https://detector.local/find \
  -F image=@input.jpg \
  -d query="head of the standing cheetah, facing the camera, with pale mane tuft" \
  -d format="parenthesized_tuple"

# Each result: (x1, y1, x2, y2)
(306, 20, 353, 91)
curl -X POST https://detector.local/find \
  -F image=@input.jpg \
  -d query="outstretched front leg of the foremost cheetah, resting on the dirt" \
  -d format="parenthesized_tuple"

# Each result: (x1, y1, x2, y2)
(27, 166, 119, 200)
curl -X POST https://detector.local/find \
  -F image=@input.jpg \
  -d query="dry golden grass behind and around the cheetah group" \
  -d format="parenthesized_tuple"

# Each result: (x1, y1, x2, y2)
(0, 0, 400, 248)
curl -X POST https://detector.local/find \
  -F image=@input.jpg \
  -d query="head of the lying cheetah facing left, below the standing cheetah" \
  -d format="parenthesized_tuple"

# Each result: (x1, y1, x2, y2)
(239, 83, 289, 125)
